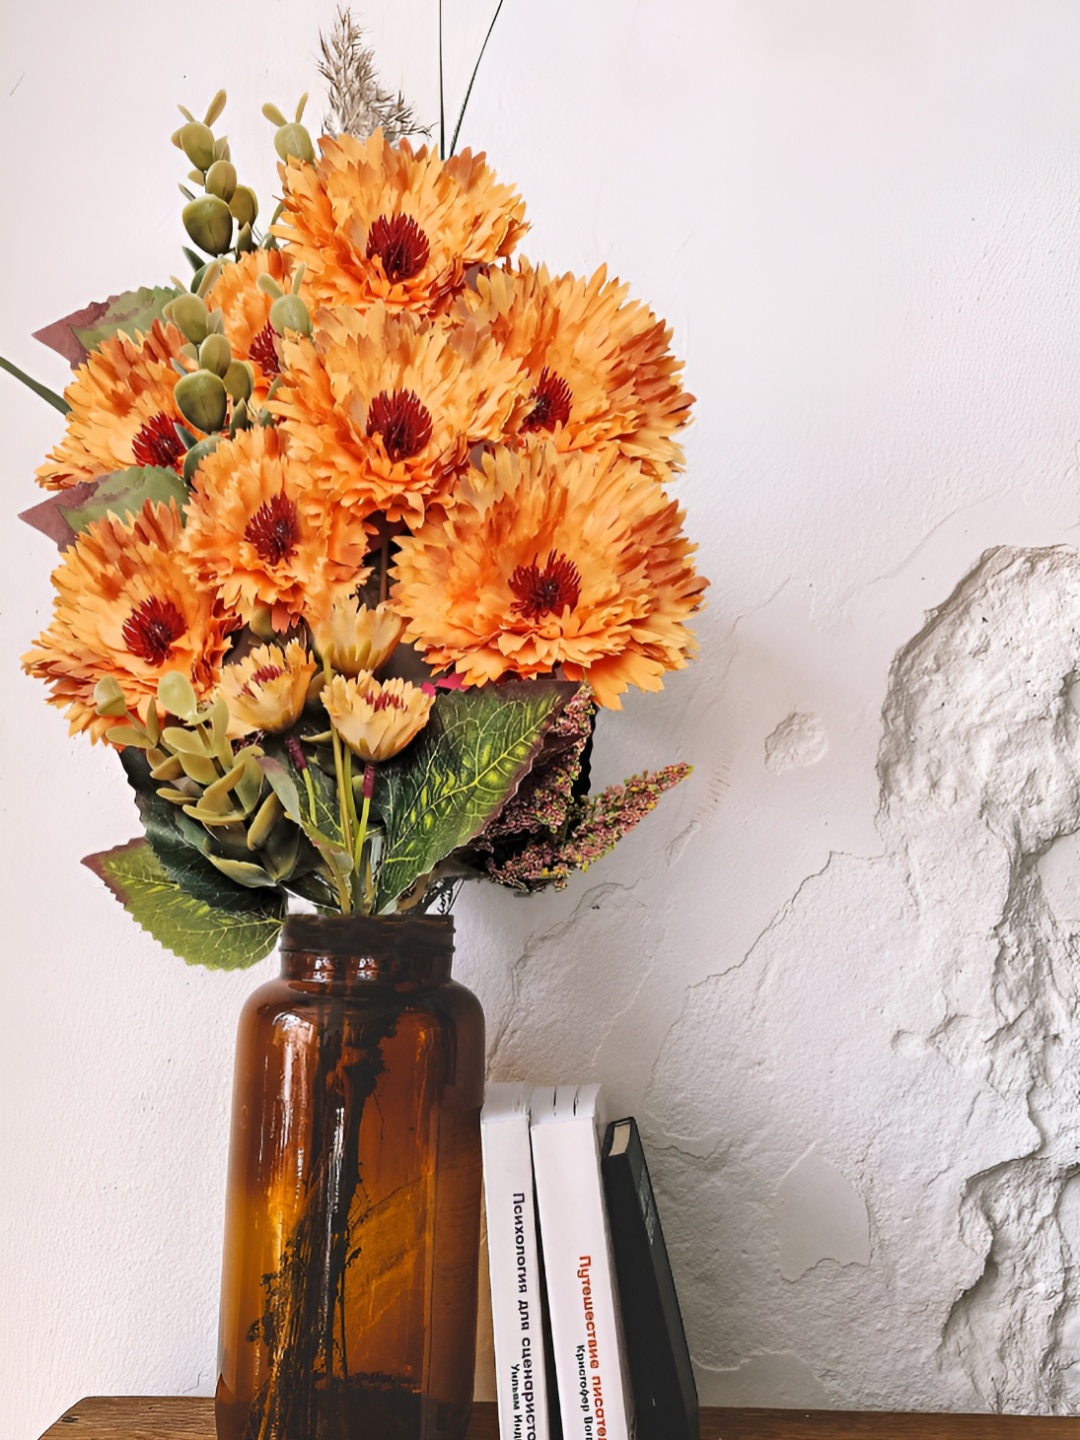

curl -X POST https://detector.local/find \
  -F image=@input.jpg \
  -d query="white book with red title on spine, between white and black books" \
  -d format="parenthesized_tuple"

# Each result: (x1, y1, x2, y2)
(530, 1084, 635, 1440)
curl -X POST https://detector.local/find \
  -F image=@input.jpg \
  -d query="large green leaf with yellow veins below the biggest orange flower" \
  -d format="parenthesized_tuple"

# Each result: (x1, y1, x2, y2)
(374, 680, 577, 910)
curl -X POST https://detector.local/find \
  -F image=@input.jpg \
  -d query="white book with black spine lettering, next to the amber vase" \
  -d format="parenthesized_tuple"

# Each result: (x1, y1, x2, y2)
(480, 1084, 550, 1440)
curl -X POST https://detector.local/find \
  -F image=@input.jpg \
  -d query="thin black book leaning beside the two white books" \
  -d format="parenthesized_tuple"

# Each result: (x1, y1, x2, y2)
(600, 1119, 700, 1440)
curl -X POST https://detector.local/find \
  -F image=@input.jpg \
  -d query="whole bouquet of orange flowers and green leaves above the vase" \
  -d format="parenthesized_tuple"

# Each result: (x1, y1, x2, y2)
(4, 17, 706, 966)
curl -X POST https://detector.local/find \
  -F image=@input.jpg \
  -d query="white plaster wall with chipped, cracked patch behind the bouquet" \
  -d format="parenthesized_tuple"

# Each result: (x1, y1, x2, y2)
(0, 0, 1080, 1440)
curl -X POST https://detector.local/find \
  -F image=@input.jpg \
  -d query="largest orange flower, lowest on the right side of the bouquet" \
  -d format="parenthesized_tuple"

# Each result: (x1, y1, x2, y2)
(392, 446, 706, 710)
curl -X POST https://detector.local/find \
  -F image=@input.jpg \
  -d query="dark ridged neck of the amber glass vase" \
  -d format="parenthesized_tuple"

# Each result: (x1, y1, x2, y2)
(281, 914, 454, 986)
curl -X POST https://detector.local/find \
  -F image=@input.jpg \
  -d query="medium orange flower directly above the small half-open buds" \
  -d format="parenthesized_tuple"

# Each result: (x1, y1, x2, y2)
(183, 425, 367, 631)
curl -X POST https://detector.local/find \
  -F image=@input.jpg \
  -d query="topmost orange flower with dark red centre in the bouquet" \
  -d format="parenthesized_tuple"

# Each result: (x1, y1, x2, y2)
(272, 130, 524, 314)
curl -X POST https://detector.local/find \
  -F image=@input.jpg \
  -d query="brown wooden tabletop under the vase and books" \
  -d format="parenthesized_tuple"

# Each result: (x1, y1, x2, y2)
(42, 1397, 1080, 1440)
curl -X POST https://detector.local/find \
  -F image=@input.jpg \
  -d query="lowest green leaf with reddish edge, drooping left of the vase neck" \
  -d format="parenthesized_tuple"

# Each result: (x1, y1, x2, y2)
(84, 840, 285, 971)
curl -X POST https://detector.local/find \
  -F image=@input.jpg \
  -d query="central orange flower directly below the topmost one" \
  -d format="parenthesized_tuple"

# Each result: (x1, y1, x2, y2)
(271, 304, 518, 528)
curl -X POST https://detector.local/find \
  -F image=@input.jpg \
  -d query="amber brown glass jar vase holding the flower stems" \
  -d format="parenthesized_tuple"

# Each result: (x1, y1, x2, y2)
(216, 916, 484, 1440)
